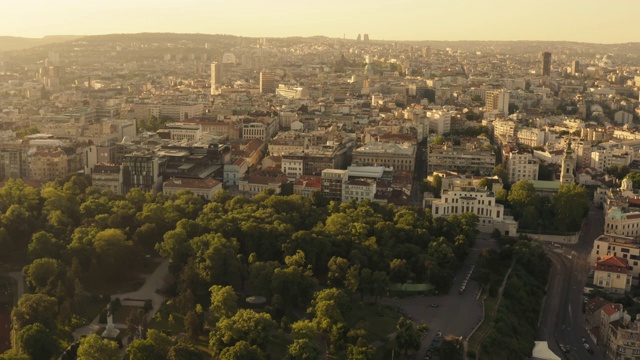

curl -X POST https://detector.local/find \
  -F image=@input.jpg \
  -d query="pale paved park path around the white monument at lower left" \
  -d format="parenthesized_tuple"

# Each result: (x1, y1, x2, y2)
(73, 260, 169, 340)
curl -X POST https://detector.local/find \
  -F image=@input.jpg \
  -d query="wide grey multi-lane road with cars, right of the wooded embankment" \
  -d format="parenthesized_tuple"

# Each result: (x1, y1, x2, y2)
(538, 208, 604, 360)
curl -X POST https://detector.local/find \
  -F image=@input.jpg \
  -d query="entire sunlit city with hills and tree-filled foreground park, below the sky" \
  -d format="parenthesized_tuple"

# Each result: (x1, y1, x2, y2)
(0, 24, 640, 360)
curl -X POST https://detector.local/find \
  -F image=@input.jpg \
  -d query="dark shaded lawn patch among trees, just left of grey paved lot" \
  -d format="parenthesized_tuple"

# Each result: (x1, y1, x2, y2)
(346, 303, 400, 343)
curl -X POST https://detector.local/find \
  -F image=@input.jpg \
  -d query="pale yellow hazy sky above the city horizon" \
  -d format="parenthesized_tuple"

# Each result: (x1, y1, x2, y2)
(0, 0, 640, 43)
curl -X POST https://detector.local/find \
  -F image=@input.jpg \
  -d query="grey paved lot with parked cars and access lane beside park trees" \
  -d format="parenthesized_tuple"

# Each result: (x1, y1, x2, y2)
(381, 239, 497, 359)
